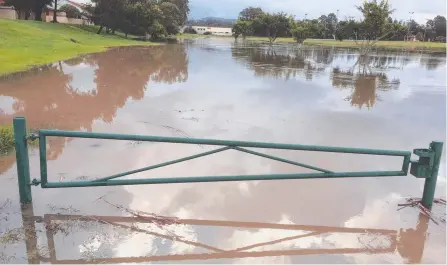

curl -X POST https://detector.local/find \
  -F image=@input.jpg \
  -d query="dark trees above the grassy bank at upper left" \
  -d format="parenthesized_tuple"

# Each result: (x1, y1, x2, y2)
(5, 0, 189, 39)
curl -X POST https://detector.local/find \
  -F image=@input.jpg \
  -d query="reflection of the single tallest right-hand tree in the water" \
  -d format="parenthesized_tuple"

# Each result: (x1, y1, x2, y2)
(331, 56, 400, 109)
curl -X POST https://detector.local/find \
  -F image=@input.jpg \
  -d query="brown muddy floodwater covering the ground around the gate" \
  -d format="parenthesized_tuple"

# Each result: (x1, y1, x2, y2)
(0, 39, 446, 263)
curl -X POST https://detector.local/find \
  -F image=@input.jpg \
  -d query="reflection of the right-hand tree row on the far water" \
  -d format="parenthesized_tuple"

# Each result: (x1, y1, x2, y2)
(232, 44, 444, 109)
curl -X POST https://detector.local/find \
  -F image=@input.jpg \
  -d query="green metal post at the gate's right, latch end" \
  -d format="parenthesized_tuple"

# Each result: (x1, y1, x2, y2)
(422, 142, 444, 209)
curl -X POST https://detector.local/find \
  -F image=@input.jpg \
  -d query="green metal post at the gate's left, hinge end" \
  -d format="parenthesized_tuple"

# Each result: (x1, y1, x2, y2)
(13, 117, 32, 204)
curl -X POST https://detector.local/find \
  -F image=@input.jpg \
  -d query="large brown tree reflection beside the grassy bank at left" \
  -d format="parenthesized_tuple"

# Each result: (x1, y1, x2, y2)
(0, 46, 188, 168)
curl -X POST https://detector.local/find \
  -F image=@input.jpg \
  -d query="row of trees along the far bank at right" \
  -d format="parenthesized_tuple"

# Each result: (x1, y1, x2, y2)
(233, 0, 446, 42)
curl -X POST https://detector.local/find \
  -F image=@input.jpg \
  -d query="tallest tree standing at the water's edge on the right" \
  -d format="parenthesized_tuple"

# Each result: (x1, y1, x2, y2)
(357, 0, 394, 40)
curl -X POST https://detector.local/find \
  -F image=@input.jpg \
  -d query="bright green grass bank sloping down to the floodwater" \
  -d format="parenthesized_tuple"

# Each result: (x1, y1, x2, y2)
(0, 19, 158, 75)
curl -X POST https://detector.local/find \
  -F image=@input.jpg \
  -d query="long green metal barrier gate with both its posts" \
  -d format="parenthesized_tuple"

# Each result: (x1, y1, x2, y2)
(14, 117, 443, 209)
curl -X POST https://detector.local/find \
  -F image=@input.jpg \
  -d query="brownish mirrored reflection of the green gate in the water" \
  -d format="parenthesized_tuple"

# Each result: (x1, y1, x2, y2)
(5, 202, 429, 264)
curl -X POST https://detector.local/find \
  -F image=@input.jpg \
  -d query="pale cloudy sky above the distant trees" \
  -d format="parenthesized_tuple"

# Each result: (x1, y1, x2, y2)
(190, 0, 446, 23)
